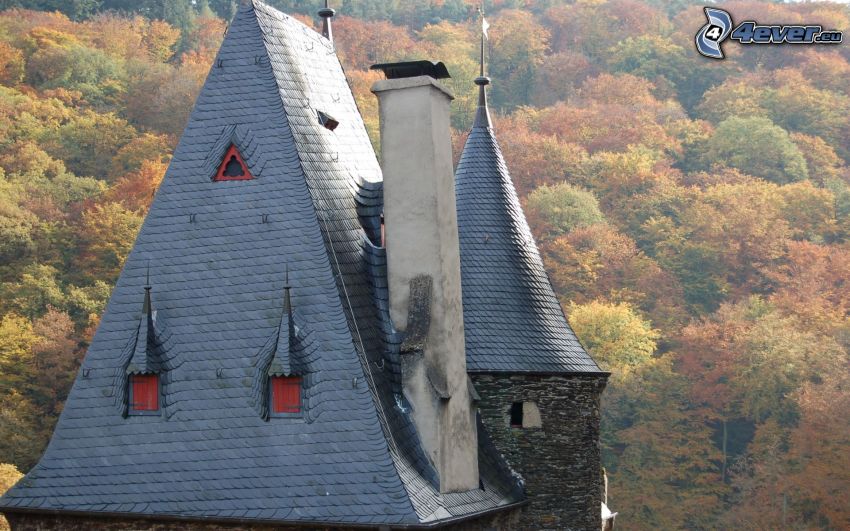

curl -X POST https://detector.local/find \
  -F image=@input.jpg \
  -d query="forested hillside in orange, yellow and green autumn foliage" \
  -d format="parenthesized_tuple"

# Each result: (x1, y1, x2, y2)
(0, 0, 850, 529)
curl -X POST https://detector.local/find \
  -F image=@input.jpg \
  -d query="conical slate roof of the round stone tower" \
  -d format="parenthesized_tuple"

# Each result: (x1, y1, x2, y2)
(455, 80, 602, 374)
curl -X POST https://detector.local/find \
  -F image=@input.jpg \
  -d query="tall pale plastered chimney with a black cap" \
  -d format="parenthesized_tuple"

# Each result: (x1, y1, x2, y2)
(372, 61, 479, 492)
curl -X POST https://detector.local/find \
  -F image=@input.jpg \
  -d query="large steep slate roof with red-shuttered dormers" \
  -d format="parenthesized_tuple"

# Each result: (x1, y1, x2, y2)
(0, 1, 523, 526)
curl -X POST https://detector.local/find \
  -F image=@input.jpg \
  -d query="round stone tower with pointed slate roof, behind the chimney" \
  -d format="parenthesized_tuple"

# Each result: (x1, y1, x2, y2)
(456, 27, 608, 529)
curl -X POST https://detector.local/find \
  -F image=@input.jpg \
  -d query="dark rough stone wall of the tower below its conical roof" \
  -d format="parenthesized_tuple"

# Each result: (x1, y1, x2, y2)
(472, 374, 606, 531)
